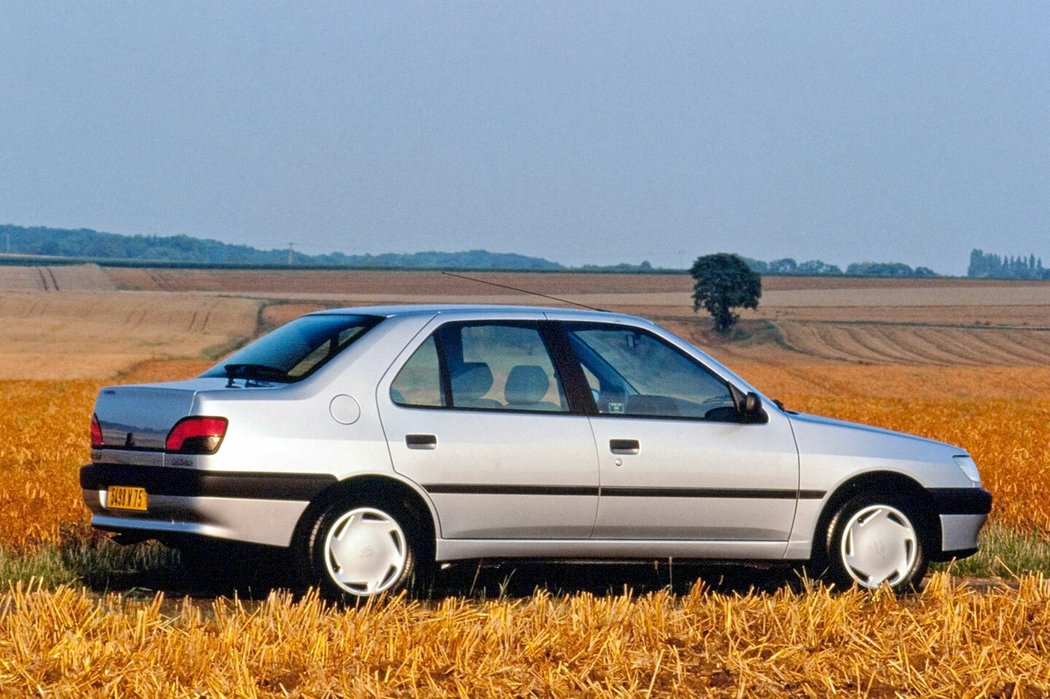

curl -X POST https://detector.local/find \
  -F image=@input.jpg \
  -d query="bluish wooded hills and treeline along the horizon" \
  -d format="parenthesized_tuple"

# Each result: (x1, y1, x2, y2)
(0, 225, 1050, 279)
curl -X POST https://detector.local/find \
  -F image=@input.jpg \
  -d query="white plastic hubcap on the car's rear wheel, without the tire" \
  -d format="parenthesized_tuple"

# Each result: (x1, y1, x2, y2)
(324, 508, 408, 596)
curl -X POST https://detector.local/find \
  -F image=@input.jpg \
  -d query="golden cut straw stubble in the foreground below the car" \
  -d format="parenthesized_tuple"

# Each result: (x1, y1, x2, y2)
(0, 574, 1050, 697)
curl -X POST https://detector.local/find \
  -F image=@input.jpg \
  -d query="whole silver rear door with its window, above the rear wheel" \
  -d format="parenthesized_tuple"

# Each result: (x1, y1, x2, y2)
(379, 317, 599, 539)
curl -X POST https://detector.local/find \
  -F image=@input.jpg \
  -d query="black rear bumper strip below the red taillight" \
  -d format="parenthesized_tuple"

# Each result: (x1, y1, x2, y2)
(80, 464, 336, 501)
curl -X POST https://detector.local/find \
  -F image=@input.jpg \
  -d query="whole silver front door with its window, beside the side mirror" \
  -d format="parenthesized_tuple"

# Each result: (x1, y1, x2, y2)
(566, 324, 799, 555)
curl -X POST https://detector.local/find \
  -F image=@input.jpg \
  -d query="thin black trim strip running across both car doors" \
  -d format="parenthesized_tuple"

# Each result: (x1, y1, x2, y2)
(423, 484, 825, 500)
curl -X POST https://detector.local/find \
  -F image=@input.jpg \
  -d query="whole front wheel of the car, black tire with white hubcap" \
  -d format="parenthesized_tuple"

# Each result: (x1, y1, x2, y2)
(825, 495, 929, 594)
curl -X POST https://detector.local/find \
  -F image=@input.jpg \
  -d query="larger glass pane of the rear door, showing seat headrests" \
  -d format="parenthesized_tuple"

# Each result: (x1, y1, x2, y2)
(451, 323, 569, 412)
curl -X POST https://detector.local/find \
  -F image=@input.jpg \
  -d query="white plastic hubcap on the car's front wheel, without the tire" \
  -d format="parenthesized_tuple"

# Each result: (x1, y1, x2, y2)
(841, 505, 919, 588)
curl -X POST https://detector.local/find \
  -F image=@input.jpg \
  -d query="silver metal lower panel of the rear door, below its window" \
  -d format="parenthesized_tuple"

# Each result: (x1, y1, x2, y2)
(382, 404, 599, 539)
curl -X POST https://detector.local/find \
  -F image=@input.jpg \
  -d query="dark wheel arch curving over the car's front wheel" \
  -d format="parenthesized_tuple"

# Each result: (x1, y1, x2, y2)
(811, 471, 941, 560)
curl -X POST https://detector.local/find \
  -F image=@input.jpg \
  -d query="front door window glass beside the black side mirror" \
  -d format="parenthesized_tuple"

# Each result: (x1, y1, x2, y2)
(569, 326, 735, 420)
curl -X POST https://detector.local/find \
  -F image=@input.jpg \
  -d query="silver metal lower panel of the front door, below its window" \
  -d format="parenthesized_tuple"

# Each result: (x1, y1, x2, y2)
(590, 414, 799, 541)
